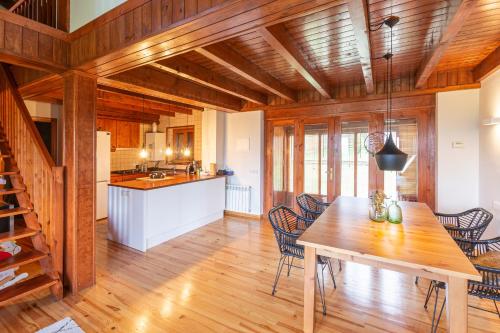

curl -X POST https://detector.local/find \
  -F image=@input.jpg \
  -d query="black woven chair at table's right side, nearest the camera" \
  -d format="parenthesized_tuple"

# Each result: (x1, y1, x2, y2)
(424, 237, 500, 332)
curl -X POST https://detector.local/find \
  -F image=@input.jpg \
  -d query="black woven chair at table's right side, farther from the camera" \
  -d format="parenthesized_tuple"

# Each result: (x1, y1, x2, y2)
(415, 208, 493, 284)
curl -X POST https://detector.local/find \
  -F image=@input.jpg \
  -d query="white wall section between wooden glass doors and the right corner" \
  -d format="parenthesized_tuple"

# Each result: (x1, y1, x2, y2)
(436, 89, 479, 213)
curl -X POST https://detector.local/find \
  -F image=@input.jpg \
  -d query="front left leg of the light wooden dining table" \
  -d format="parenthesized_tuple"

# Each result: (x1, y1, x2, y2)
(304, 246, 316, 333)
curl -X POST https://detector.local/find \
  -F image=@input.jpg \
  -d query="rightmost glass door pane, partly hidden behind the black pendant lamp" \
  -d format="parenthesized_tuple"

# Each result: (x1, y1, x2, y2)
(384, 119, 418, 201)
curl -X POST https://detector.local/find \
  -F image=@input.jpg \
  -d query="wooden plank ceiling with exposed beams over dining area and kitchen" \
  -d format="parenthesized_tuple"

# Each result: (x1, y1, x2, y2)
(7, 0, 500, 111)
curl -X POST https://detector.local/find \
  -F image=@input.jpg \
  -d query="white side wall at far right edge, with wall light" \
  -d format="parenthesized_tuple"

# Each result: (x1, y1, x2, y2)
(479, 70, 500, 238)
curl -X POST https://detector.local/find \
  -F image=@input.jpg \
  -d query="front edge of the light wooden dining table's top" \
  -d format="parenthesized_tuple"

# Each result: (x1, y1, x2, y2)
(297, 239, 483, 282)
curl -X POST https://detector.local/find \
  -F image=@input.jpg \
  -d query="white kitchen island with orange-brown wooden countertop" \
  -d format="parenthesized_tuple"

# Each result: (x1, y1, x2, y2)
(108, 174, 225, 252)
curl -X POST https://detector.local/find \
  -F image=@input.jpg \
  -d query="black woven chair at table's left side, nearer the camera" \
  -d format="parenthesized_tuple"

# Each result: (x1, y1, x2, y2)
(268, 205, 337, 315)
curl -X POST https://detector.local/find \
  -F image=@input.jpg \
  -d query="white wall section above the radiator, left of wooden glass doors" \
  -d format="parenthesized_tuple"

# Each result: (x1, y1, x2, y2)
(225, 111, 264, 215)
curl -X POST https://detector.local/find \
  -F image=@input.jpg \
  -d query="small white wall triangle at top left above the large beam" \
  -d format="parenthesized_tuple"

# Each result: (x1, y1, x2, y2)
(69, 0, 126, 32)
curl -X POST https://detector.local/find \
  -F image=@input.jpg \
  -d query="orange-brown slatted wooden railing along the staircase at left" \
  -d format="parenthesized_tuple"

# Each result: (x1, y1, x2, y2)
(0, 64, 64, 276)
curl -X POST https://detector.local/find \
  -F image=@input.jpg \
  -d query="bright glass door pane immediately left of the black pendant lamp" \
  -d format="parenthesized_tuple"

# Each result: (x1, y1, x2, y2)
(340, 121, 369, 197)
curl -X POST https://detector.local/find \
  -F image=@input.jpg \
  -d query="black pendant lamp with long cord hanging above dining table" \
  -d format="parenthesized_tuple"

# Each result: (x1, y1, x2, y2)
(375, 16, 408, 171)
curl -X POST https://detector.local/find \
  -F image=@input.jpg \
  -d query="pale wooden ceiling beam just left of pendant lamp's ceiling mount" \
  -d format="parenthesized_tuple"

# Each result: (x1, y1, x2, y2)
(347, 0, 374, 94)
